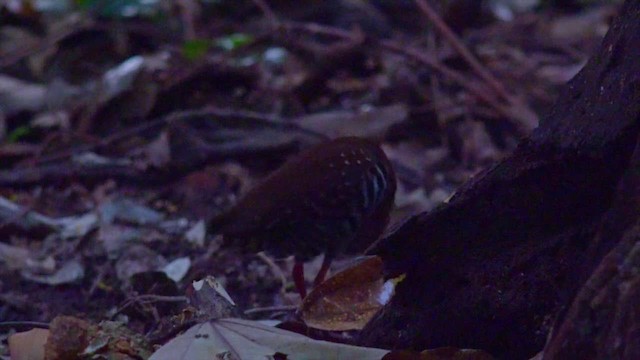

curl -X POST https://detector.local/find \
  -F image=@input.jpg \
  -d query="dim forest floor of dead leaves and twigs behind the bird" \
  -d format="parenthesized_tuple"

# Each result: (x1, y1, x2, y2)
(0, 0, 618, 355)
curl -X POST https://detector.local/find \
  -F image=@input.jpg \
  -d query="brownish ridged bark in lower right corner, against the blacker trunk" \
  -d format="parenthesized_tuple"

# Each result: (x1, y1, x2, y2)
(543, 134, 640, 360)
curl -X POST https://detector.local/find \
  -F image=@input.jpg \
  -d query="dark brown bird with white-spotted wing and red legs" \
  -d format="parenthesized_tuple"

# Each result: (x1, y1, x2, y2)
(210, 137, 396, 298)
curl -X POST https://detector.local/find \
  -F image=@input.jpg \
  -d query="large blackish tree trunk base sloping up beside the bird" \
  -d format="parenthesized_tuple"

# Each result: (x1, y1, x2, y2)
(361, 0, 640, 359)
